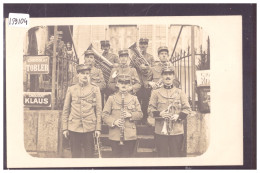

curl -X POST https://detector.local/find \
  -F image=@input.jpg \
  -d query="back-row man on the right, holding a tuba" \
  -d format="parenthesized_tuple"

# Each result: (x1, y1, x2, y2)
(132, 38, 154, 124)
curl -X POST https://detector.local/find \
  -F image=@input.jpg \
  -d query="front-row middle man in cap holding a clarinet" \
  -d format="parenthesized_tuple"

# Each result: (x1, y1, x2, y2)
(102, 74, 143, 157)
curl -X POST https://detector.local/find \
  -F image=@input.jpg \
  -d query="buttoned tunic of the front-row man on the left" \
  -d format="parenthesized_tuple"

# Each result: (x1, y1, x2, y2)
(62, 84, 102, 133)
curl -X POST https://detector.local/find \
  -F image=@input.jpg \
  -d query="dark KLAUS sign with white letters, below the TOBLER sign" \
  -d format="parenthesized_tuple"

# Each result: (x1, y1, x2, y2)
(23, 92, 51, 107)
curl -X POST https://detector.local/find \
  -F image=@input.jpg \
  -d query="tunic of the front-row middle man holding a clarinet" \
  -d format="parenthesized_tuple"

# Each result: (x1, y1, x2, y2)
(102, 92, 143, 141)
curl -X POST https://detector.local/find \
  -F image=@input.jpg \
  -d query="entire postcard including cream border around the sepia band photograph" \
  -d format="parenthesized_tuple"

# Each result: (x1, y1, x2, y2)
(6, 10, 246, 167)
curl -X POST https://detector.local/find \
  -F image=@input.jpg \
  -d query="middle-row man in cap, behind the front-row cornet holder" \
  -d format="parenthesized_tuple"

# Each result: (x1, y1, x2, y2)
(148, 46, 181, 89)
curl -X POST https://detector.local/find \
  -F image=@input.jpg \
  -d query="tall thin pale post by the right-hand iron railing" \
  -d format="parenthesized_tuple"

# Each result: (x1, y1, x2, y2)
(191, 26, 195, 110)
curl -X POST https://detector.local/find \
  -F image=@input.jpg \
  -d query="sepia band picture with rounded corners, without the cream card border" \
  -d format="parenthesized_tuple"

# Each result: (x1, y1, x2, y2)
(23, 24, 210, 158)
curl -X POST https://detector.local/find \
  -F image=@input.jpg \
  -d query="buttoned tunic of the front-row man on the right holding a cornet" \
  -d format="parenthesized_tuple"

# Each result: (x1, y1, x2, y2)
(148, 87, 190, 135)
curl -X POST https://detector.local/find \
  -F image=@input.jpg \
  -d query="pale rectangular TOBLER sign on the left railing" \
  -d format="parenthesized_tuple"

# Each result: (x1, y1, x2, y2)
(25, 56, 49, 74)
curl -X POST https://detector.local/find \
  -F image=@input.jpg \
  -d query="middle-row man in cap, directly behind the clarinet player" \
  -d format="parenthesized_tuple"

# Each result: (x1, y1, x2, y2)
(108, 49, 141, 94)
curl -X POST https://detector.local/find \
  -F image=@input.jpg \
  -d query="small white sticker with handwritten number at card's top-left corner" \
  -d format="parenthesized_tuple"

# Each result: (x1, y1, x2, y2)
(8, 13, 30, 27)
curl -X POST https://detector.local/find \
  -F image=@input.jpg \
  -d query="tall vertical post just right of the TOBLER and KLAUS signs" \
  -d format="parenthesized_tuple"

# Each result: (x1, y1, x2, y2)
(51, 26, 58, 110)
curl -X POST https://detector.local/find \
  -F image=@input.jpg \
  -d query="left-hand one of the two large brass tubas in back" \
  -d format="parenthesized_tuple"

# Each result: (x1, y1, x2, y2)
(88, 44, 113, 83)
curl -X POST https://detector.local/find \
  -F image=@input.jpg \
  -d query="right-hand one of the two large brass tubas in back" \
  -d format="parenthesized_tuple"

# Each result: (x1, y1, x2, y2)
(129, 42, 150, 72)
